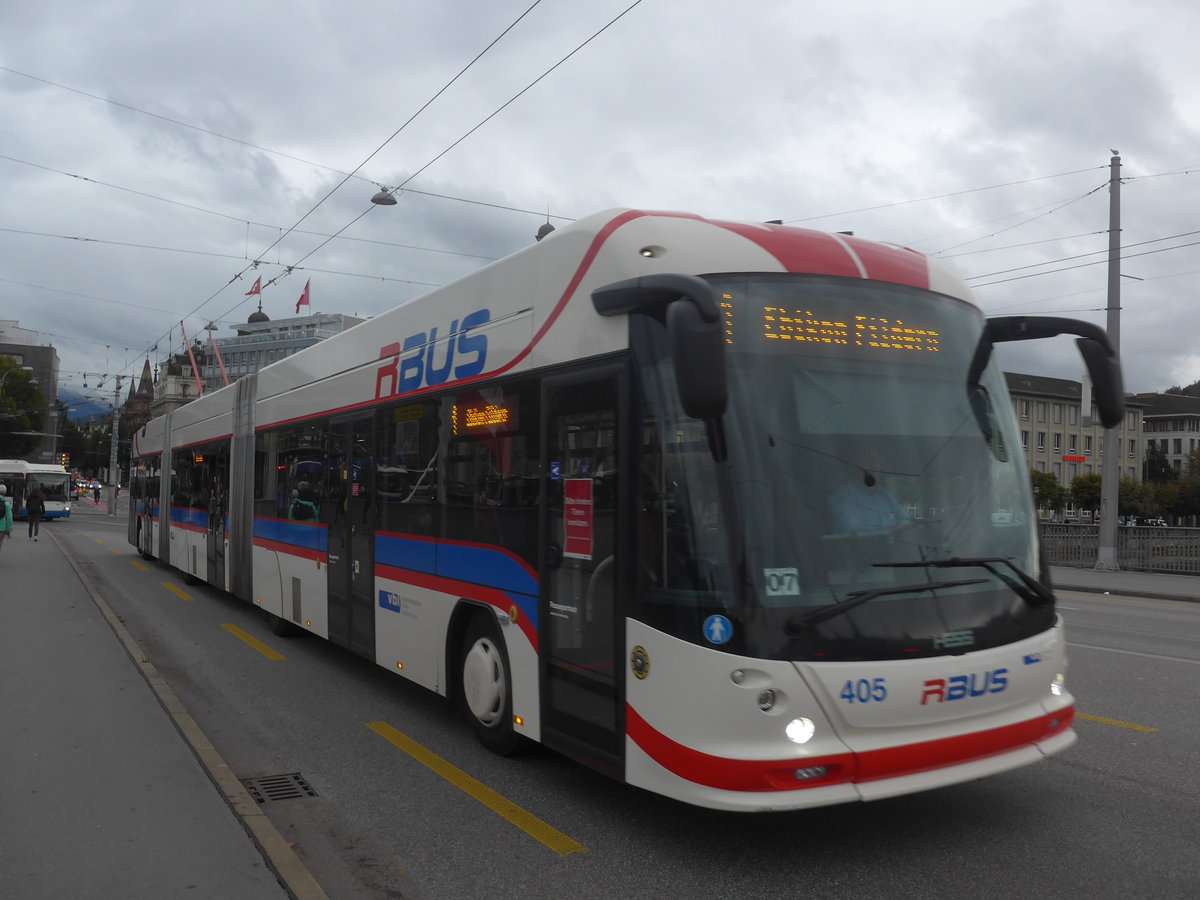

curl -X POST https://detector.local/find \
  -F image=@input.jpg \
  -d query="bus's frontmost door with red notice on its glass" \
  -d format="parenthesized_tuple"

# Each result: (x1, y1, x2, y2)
(539, 367, 624, 778)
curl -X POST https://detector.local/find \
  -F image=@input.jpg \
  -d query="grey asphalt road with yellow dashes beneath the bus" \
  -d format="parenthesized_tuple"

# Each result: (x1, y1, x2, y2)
(49, 508, 1200, 900)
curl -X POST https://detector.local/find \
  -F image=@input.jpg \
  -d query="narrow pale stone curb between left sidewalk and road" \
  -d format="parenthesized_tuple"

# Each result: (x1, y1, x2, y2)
(50, 534, 329, 900)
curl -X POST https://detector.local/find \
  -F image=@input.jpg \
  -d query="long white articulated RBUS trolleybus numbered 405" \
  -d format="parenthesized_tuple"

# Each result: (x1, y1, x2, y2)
(130, 210, 1122, 810)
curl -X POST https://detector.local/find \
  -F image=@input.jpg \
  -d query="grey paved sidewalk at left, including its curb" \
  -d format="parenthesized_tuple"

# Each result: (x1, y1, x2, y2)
(0, 522, 323, 900)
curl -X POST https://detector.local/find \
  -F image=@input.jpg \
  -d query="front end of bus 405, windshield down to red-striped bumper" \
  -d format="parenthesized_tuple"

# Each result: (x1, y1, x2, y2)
(625, 274, 1074, 810)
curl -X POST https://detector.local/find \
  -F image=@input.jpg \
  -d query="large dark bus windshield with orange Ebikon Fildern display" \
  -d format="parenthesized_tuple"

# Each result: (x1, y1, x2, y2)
(634, 275, 1054, 659)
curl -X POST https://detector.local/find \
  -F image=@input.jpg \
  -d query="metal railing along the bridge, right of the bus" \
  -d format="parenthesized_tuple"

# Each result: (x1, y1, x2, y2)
(1039, 522, 1200, 575)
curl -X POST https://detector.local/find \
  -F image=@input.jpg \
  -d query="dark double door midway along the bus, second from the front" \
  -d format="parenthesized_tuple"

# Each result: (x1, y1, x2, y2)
(320, 418, 376, 660)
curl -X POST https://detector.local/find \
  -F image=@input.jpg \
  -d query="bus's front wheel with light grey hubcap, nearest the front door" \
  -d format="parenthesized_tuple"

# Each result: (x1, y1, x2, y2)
(458, 612, 523, 756)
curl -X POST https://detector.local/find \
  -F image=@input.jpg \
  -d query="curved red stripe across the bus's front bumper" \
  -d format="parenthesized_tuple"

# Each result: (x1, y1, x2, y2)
(625, 704, 1075, 791)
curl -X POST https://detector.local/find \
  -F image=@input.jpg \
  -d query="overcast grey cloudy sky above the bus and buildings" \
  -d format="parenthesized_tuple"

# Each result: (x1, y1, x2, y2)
(0, 0, 1200, 412)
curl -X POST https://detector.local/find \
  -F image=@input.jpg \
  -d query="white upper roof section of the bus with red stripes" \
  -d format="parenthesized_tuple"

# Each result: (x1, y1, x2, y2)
(136, 209, 971, 446)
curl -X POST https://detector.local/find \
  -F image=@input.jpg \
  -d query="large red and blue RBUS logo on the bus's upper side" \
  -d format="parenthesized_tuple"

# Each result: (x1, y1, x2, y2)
(376, 310, 492, 400)
